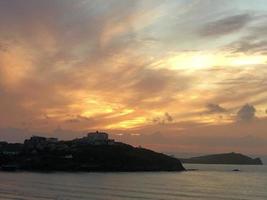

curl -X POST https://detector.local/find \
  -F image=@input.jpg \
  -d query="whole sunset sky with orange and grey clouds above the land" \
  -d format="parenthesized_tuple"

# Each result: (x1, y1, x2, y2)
(0, 0, 267, 155)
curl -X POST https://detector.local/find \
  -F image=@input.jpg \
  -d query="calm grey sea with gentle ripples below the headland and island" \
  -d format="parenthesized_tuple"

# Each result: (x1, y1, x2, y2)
(0, 165, 267, 200)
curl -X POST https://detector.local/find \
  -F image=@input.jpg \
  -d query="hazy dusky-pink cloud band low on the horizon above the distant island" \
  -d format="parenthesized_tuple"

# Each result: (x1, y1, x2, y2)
(111, 118, 267, 155)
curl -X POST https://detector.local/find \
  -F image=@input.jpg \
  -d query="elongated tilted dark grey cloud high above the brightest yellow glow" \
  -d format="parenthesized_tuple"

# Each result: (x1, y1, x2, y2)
(199, 14, 253, 37)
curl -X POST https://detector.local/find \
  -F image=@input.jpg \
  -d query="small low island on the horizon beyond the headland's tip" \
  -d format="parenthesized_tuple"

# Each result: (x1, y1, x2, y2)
(180, 152, 263, 165)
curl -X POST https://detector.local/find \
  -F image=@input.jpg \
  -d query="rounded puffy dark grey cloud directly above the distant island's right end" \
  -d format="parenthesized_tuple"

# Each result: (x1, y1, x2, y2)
(236, 104, 256, 122)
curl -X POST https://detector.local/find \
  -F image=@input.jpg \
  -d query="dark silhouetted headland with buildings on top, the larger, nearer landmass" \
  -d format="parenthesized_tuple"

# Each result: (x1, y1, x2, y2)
(0, 132, 185, 172)
